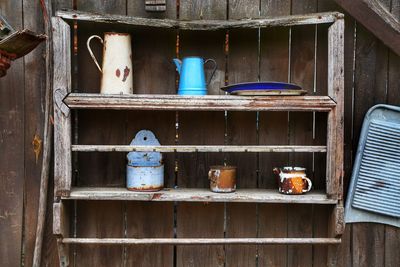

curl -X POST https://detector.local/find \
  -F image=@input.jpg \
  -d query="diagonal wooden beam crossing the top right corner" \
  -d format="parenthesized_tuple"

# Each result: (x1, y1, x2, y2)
(335, 0, 400, 55)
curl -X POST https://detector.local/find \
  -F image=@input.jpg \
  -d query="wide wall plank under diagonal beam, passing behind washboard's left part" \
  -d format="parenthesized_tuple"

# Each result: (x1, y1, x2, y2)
(352, 24, 388, 266)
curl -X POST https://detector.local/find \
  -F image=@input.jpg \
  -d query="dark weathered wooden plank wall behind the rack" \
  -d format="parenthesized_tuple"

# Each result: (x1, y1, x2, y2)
(0, 0, 400, 266)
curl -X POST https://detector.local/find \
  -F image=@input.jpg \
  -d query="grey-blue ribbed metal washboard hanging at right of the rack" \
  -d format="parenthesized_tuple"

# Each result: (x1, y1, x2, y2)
(345, 105, 400, 227)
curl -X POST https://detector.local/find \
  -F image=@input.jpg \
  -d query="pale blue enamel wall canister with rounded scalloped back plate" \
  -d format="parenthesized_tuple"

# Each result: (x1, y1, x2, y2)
(126, 130, 164, 191)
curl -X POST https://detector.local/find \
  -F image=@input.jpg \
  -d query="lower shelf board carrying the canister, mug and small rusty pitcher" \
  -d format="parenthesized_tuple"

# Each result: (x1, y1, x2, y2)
(63, 187, 337, 204)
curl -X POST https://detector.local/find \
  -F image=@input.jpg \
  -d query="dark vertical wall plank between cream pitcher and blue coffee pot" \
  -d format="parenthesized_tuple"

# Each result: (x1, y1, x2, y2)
(126, 0, 177, 266)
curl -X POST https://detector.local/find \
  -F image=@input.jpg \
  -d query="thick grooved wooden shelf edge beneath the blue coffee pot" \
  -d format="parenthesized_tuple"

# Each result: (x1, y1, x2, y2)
(64, 93, 336, 112)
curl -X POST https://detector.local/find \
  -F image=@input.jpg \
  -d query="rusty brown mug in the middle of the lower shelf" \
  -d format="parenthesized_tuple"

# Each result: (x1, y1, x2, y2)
(208, 166, 236, 193)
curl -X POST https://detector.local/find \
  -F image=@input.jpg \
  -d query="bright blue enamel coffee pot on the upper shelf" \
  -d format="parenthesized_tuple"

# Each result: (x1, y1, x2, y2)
(173, 57, 217, 95)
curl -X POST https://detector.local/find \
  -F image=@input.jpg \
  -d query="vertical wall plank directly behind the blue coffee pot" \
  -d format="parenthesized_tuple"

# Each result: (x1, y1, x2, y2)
(176, 0, 227, 266)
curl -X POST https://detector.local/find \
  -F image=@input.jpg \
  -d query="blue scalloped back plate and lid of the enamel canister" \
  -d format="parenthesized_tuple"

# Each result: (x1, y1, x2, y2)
(127, 130, 162, 167)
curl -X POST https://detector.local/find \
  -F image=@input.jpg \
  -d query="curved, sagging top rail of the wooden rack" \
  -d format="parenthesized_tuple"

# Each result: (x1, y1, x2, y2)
(56, 9, 344, 31)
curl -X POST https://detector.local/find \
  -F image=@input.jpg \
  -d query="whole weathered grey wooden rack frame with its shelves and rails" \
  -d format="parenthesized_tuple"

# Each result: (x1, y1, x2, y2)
(52, 11, 344, 266)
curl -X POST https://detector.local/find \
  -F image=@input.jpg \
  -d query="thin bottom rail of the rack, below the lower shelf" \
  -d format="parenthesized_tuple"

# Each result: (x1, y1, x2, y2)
(62, 238, 341, 245)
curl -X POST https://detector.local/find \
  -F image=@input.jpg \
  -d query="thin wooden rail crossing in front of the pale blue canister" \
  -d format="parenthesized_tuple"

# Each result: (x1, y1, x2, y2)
(72, 145, 326, 153)
